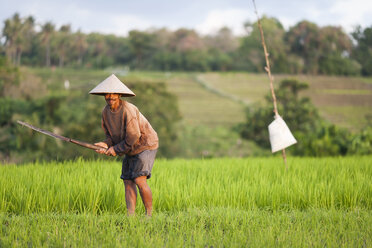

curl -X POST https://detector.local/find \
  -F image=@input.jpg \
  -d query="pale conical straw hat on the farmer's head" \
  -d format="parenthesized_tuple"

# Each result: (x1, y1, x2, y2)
(89, 74, 136, 96)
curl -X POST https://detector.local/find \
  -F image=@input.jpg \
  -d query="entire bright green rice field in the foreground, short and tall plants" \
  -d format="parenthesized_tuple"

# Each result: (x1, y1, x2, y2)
(0, 156, 372, 247)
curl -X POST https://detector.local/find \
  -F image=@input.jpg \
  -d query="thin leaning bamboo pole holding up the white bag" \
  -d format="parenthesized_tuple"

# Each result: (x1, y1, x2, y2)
(252, 0, 288, 171)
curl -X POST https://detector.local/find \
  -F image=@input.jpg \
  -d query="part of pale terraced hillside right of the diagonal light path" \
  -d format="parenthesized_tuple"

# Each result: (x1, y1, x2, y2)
(199, 73, 372, 131)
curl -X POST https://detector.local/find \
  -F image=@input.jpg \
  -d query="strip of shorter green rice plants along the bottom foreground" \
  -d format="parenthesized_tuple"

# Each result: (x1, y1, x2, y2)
(0, 207, 372, 247)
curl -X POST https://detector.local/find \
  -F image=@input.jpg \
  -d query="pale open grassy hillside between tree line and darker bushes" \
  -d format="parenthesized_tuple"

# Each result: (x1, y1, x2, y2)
(30, 69, 372, 131)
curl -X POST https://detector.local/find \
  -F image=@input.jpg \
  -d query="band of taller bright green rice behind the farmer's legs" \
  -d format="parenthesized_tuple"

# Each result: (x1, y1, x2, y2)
(0, 157, 372, 214)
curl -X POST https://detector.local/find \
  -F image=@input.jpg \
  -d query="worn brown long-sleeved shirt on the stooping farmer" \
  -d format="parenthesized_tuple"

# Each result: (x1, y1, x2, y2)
(102, 100, 159, 155)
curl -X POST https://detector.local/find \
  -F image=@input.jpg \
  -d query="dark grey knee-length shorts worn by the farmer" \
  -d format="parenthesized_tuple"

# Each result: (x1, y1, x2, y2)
(120, 149, 158, 180)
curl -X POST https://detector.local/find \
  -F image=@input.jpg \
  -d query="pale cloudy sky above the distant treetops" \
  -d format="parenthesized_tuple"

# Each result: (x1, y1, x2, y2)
(0, 0, 372, 36)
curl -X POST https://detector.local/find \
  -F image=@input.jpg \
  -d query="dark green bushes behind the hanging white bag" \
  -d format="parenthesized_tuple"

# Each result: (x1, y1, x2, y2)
(238, 79, 372, 156)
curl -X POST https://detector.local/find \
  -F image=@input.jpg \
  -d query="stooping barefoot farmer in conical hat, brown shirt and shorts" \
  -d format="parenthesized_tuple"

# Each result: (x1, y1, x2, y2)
(89, 74, 158, 216)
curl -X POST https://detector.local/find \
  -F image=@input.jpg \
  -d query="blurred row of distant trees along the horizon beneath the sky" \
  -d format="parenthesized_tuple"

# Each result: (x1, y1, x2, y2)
(0, 13, 372, 75)
